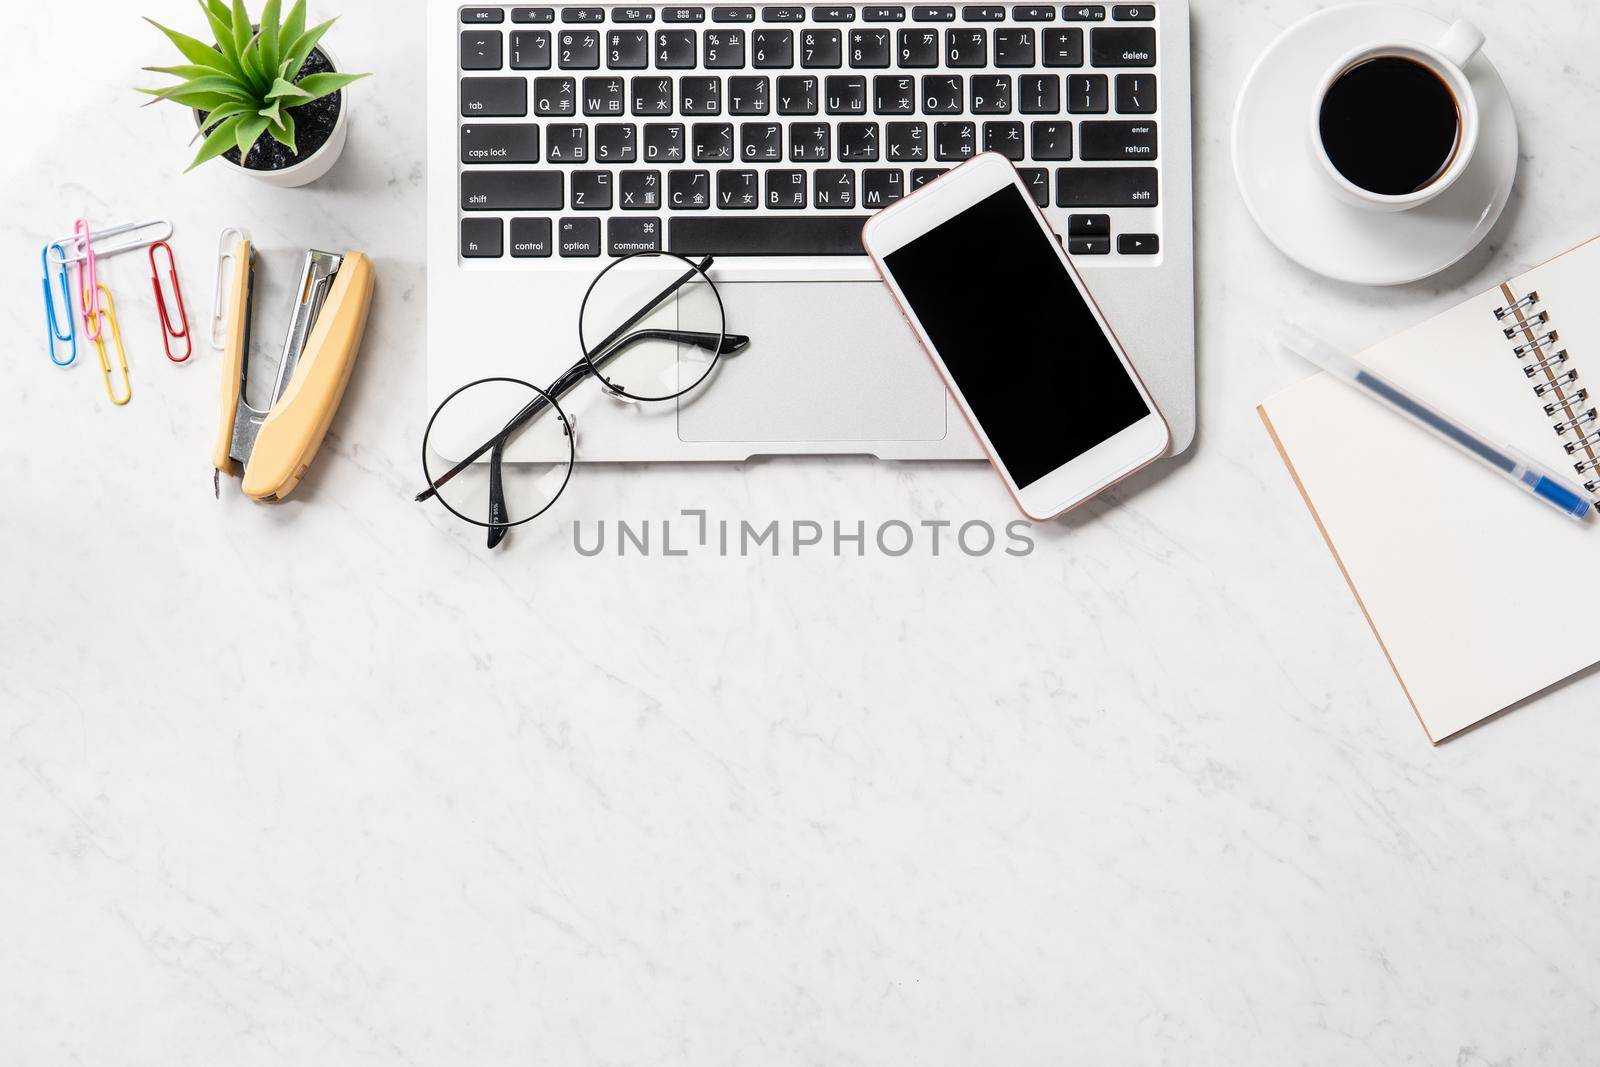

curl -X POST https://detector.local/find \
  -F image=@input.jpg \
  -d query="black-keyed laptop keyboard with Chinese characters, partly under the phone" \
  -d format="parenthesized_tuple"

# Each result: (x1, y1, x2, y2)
(459, 3, 1162, 266)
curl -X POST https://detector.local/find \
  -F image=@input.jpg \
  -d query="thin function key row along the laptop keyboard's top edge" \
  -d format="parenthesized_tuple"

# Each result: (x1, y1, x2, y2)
(461, 3, 1155, 26)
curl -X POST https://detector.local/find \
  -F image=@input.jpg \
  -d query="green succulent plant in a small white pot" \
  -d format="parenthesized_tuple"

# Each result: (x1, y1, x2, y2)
(139, 0, 366, 187)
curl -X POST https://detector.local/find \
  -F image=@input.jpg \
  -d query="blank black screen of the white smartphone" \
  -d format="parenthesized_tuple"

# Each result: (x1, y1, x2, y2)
(883, 186, 1150, 488)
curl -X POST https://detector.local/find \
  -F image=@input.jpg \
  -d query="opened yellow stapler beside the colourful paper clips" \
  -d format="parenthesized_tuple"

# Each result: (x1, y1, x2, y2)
(211, 234, 374, 504)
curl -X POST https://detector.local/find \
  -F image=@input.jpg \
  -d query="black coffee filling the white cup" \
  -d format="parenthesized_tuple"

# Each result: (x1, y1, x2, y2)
(1317, 56, 1461, 197)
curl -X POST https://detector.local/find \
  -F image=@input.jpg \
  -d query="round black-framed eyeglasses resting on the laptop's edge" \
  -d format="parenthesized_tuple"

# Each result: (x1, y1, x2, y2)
(416, 253, 750, 549)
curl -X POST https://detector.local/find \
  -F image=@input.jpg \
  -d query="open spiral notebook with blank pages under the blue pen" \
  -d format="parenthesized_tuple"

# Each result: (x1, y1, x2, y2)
(1258, 238, 1600, 742)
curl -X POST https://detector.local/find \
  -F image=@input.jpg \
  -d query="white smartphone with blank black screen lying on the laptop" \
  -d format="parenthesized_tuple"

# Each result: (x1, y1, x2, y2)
(862, 152, 1171, 520)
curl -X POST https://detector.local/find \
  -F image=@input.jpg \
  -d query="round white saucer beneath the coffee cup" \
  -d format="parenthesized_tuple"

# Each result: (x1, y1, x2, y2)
(1234, 3, 1517, 285)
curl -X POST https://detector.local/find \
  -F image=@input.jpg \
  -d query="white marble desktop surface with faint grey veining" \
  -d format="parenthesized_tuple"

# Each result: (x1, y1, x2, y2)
(0, 0, 1600, 1067)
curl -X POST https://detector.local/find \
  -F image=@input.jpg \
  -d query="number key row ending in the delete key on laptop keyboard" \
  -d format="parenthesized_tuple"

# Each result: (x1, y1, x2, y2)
(461, 26, 1155, 72)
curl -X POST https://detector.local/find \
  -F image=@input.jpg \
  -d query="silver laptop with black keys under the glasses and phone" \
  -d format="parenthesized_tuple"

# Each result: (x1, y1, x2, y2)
(426, 0, 1195, 462)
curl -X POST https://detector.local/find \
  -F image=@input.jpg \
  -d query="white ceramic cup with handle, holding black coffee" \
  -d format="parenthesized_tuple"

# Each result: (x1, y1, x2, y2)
(1310, 21, 1483, 211)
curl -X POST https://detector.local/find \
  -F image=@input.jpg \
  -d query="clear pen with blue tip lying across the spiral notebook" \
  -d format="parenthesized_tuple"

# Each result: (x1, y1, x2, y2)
(1280, 325, 1592, 522)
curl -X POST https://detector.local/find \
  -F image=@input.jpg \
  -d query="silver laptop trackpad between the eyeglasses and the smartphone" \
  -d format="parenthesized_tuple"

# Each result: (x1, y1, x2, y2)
(678, 282, 947, 442)
